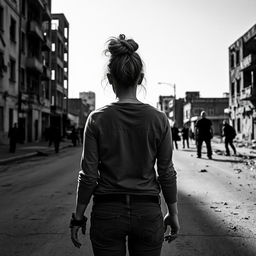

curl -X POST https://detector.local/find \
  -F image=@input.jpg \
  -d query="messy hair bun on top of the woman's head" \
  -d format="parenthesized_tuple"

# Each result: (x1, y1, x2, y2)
(108, 34, 139, 56)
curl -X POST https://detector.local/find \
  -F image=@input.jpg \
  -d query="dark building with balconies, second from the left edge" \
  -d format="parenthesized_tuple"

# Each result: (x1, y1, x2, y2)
(19, 0, 51, 141)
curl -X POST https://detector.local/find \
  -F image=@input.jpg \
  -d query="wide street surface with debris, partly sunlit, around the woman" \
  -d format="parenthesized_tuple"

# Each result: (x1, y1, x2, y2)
(0, 145, 256, 256)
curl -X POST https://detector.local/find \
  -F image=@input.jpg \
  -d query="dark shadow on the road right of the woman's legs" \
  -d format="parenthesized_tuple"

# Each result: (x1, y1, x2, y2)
(162, 191, 256, 256)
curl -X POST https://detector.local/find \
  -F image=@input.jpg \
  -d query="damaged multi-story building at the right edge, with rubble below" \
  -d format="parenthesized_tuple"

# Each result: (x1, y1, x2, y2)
(229, 25, 256, 142)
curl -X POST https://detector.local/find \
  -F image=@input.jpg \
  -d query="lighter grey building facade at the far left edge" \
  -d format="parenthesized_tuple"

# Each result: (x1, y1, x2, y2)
(0, 0, 20, 143)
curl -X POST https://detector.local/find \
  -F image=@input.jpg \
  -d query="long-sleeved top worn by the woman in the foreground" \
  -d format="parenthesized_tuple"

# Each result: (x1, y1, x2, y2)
(77, 103, 177, 204)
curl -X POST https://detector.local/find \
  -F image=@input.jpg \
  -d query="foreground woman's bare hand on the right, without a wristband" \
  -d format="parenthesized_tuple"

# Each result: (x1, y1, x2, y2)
(164, 213, 180, 243)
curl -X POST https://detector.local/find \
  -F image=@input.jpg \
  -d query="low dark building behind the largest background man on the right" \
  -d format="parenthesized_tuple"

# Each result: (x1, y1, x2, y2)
(183, 92, 229, 135)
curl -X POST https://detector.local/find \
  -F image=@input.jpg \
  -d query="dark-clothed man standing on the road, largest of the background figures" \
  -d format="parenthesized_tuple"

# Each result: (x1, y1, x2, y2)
(195, 111, 213, 159)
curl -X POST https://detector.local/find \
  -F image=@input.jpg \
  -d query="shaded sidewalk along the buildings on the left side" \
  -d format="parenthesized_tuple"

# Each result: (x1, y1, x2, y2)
(0, 139, 72, 165)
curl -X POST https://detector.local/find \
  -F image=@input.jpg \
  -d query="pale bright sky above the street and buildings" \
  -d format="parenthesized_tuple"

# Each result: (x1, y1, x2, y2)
(52, 0, 256, 108)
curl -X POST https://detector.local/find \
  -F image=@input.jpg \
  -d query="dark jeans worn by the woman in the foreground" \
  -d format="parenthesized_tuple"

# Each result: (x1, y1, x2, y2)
(90, 197, 164, 256)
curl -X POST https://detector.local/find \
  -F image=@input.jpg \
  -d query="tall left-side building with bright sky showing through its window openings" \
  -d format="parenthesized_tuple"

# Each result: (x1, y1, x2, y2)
(51, 14, 69, 134)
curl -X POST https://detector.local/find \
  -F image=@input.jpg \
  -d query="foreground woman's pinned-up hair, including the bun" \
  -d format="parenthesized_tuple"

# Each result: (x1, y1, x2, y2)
(105, 34, 143, 87)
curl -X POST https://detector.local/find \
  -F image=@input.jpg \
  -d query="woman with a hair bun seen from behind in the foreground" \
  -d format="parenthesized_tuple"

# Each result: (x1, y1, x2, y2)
(70, 35, 179, 256)
